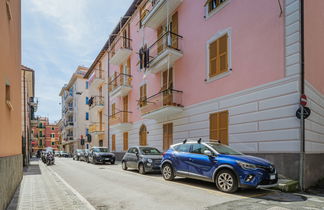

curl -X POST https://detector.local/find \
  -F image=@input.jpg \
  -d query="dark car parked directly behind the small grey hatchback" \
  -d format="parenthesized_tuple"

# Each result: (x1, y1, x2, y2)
(88, 147, 116, 164)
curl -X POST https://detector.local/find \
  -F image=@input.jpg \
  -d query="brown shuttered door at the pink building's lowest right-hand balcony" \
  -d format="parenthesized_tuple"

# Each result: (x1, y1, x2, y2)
(161, 68, 173, 106)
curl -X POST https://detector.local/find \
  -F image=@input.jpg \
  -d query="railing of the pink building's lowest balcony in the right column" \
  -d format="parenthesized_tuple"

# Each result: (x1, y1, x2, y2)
(138, 89, 183, 117)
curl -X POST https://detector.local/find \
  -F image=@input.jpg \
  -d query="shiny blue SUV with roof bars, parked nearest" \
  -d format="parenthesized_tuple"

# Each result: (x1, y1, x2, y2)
(161, 139, 278, 193)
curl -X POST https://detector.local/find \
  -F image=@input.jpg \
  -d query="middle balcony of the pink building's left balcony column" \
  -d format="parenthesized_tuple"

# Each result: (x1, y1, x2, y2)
(108, 73, 132, 98)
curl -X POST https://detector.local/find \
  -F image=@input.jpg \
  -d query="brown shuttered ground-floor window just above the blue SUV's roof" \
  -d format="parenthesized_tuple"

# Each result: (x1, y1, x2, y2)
(209, 111, 228, 144)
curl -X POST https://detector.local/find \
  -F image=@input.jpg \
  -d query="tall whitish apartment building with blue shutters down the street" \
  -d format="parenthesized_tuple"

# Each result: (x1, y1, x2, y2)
(60, 66, 90, 152)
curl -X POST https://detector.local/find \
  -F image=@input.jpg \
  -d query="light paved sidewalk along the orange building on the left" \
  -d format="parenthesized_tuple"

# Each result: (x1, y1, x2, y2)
(7, 160, 92, 210)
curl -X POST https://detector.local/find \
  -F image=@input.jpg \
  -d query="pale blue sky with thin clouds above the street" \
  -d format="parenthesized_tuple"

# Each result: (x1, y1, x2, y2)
(22, 0, 132, 122)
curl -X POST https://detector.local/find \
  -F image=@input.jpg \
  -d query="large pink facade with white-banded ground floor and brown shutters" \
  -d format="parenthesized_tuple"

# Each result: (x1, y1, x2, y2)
(85, 0, 324, 186)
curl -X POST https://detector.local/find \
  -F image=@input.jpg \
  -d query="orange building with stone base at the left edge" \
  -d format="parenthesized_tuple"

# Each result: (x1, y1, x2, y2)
(0, 0, 23, 209)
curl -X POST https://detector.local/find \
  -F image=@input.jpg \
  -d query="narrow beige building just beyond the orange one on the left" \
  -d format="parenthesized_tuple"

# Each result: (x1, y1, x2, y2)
(21, 65, 38, 166)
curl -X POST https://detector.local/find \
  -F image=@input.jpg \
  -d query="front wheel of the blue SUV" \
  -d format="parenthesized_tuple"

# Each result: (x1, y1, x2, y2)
(215, 169, 238, 193)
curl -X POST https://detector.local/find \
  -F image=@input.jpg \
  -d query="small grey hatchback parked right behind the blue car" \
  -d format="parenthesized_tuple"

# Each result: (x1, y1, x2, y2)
(122, 146, 162, 174)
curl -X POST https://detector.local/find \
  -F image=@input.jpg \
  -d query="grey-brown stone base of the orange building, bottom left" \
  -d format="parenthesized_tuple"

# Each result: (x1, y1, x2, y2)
(0, 154, 23, 209)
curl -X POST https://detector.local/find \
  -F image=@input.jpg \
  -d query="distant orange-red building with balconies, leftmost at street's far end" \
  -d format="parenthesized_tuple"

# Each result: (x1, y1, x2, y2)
(31, 116, 49, 155)
